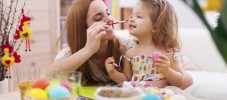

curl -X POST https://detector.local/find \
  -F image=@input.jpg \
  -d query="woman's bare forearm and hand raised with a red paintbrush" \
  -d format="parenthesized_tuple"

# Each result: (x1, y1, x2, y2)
(45, 22, 109, 73)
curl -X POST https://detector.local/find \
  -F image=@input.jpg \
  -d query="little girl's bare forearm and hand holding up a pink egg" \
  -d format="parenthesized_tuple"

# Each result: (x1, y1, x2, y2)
(157, 55, 193, 89)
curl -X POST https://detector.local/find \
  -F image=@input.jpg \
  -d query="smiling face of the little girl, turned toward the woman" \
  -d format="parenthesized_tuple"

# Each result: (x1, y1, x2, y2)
(129, 2, 153, 37)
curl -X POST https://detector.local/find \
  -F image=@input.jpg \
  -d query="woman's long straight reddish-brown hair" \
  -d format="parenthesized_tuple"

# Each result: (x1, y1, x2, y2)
(60, 0, 121, 85)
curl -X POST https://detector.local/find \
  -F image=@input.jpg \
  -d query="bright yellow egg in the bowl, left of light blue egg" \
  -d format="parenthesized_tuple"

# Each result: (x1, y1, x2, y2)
(28, 88, 48, 99)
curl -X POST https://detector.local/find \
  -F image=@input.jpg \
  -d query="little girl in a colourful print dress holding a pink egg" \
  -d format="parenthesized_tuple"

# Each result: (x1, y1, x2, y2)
(105, 0, 192, 89)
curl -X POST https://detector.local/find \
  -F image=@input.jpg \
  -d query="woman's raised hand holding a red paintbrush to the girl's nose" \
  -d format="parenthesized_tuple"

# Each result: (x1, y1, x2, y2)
(85, 22, 109, 53)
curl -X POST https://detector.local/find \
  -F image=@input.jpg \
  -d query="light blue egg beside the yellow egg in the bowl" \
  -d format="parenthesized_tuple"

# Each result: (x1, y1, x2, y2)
(49, 85, 70, 99)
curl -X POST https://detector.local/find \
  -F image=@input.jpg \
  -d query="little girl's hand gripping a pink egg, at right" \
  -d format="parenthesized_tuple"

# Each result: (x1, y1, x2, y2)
(154, 55, 170, 73)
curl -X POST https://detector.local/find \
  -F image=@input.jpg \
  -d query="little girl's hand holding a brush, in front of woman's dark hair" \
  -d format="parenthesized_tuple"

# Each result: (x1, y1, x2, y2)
(105, 57, 115, 74)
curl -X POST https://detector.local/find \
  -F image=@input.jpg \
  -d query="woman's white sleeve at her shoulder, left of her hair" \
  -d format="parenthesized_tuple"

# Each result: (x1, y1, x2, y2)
(54, 47, 71, 60)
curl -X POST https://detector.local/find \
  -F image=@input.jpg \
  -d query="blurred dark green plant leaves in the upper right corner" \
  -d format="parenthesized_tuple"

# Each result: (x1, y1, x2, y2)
(183, 0, 227, 62)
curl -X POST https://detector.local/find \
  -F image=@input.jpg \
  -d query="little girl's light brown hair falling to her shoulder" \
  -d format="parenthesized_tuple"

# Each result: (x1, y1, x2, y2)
(140, 0, 180, 51)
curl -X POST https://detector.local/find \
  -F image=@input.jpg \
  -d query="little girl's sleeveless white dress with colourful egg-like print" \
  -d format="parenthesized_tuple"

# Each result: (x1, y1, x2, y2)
(130, 55, 164, 81)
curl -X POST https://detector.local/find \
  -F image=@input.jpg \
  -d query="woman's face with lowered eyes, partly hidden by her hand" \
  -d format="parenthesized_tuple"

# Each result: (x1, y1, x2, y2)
(87, 0, 115, 40)
